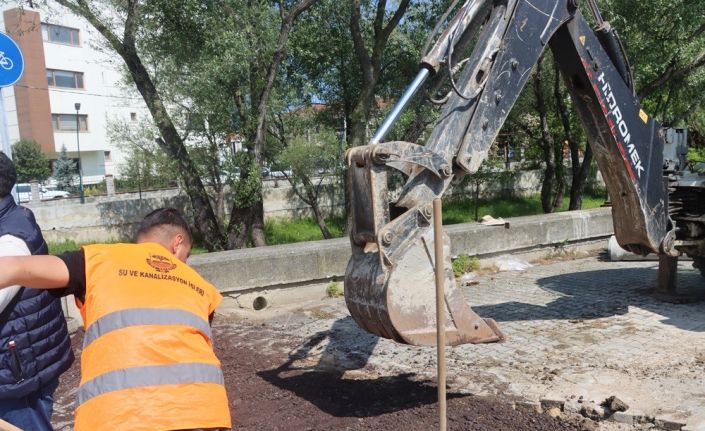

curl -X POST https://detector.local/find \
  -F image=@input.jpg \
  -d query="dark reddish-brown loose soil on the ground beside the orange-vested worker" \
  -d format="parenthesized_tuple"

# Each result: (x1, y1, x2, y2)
(48, 316, 579, 431)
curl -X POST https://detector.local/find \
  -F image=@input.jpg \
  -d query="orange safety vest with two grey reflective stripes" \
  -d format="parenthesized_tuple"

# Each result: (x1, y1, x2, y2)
(75, 243, 231, 431)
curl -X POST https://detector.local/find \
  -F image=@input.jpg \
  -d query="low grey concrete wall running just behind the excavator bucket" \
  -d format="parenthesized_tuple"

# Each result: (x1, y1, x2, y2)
(189, 208, 613, 292)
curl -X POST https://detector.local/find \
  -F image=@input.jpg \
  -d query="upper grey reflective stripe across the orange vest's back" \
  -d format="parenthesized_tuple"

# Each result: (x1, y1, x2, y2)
(83, 308, 213, 349)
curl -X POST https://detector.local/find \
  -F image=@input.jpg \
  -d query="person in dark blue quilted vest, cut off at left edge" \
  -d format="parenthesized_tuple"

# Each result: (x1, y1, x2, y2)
(0, 152, 74, 431)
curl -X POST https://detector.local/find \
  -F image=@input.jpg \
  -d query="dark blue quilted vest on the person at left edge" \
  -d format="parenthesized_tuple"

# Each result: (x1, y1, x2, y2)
(0, 195, 73, 400)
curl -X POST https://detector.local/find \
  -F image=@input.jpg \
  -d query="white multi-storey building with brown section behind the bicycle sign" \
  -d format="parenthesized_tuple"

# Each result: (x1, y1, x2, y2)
(0, 7, 148, 184)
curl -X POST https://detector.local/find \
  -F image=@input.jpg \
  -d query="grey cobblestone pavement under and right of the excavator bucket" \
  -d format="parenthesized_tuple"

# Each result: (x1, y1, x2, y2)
(238, 258, 705, 430)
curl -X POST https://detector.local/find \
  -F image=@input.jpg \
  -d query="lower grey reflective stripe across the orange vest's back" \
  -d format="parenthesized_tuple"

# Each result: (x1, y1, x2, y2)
(76, 363, 225, 407)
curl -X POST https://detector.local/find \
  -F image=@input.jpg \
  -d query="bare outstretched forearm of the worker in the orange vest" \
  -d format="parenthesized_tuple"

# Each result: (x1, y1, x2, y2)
(0, 256, 69, 289)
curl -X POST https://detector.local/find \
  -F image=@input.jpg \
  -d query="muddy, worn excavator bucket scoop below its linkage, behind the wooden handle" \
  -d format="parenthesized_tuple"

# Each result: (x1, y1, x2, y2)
(345, 228, 504, 346)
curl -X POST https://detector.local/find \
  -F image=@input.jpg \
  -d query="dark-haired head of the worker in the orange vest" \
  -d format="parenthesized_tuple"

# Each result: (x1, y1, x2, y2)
(137, 208, 193, 262)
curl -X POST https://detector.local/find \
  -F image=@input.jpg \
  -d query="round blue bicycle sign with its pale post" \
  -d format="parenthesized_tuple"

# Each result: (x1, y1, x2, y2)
(0, 32, 24, 200)
